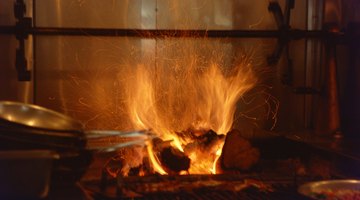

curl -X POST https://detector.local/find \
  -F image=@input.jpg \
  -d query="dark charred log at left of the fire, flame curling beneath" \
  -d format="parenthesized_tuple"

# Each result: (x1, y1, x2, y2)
(153, 138, 190, 174)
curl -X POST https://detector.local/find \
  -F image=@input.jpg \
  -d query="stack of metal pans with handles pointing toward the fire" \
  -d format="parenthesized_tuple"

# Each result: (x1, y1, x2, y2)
(0, 101, 151, 181)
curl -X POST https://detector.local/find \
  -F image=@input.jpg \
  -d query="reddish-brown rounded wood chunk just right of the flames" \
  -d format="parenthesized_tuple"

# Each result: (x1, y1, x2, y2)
(220, 130, 260, 170)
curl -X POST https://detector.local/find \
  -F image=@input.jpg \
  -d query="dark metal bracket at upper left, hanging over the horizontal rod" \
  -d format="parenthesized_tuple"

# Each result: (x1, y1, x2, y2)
(14, 0, 32, 81)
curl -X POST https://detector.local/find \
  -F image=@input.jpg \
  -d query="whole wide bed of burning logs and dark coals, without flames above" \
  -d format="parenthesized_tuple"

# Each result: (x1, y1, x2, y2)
(102, 127, 331, 179)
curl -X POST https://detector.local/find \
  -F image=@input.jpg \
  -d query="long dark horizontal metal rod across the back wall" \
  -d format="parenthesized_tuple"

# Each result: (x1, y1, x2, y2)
(0, 26, 344, 39)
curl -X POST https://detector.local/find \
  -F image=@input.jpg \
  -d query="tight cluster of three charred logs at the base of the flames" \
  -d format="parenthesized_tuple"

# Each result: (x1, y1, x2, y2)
(149, 130, 260, 174)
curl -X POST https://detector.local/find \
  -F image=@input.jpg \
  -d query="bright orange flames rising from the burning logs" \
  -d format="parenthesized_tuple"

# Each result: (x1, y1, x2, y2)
(124, 39, 257, 174)
